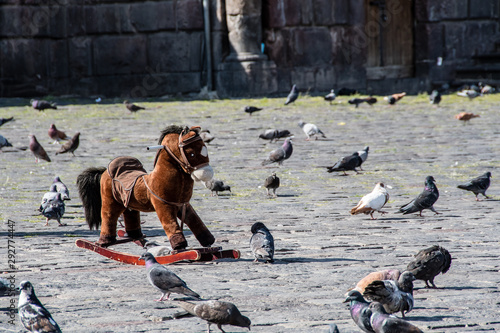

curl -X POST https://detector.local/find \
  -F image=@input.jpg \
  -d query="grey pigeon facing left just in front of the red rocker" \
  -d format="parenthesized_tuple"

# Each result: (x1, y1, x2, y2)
(139, 252, 200, 302)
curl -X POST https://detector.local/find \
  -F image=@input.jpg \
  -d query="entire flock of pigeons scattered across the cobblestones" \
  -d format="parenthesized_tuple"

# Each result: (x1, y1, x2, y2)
(0, 85, 491, 333)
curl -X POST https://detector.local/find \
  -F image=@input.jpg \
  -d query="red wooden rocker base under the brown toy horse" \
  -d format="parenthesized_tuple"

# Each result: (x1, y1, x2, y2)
(75, 230, 240, 265)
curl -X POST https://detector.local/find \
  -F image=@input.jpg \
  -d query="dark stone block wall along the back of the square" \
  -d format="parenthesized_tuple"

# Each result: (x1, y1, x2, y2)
(0, 0, 500, 97)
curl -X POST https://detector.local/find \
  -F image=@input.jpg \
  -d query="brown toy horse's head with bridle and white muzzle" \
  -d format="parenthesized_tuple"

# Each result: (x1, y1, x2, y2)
(160, 126, 214, 182)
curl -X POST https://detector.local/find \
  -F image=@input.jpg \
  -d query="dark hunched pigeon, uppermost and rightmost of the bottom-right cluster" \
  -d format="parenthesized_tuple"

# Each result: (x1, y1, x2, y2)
(406, 245, 451, 288)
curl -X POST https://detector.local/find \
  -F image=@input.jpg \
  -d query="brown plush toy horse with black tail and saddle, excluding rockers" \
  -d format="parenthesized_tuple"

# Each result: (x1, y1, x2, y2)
(77, 125, 215, 250)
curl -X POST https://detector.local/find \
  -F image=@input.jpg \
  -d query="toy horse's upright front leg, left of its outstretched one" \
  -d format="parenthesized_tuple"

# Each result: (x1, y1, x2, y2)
(153, 201, 187, 250)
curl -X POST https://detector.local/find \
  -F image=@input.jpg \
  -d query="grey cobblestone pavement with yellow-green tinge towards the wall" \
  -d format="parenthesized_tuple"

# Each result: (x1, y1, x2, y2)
(0, 95, 500, 332)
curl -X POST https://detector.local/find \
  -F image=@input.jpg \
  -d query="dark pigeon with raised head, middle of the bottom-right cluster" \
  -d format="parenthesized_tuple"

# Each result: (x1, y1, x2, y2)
(363, 271, 415, 318)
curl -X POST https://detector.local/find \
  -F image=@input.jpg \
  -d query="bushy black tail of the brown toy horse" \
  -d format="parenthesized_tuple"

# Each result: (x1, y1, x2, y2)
(76, 167, 106, 230)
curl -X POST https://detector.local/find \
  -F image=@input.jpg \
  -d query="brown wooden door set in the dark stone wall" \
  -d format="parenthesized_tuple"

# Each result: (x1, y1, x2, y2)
(365, 0, 414, 80)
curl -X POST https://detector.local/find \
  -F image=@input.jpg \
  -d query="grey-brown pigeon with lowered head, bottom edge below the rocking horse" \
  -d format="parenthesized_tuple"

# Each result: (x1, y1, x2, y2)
(177, 300, 251, 333)
